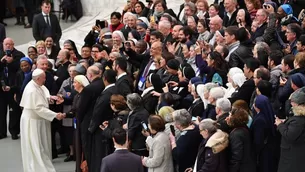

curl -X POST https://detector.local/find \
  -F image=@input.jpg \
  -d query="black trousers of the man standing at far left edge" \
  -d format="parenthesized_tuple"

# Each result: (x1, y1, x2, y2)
(0, 92, 22, 137)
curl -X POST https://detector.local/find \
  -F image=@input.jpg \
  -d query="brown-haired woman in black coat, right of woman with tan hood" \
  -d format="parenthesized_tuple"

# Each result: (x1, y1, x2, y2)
(226, 108, 256, 172)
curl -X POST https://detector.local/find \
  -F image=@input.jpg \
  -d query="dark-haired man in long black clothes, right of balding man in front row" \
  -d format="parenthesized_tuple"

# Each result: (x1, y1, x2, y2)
(87, 69, 117, 172)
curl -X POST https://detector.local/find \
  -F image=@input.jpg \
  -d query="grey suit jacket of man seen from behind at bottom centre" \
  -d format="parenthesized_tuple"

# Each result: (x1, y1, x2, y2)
(101, 150, 143, 172)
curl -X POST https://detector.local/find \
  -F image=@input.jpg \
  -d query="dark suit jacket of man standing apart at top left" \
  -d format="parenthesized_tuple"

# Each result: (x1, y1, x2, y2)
(32, 13, 62, 45)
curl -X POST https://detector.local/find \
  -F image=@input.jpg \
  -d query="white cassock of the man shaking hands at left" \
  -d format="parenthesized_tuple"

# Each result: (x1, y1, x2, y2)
(20, 80, 57, 172)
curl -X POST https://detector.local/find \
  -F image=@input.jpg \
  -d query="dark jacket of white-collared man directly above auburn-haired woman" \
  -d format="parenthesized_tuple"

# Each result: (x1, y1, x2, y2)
(115, 75, 133, 97)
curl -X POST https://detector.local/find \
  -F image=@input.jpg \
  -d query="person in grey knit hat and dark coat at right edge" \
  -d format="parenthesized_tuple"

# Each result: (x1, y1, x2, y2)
(275, 87, 305, 172)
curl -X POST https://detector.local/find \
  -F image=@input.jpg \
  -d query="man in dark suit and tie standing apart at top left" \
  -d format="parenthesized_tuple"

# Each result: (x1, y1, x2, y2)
(32, 0, 62, 46)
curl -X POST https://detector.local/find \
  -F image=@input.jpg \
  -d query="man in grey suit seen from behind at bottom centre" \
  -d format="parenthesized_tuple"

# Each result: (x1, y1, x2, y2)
(101, 128, 143, 172)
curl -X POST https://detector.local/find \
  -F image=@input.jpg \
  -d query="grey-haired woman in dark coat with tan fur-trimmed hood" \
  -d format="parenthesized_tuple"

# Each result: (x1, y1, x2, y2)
(186, 119, 229, 172)
